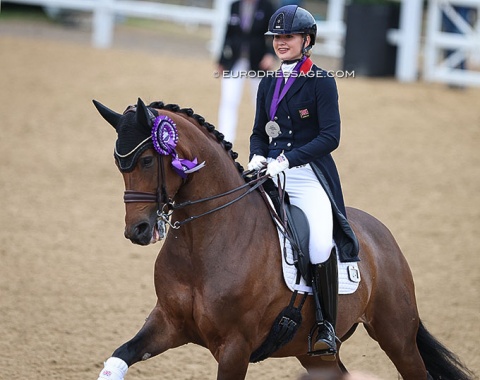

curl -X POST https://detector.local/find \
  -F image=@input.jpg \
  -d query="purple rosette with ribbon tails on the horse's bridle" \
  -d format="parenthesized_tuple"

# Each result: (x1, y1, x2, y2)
(152, 115, 205, 179)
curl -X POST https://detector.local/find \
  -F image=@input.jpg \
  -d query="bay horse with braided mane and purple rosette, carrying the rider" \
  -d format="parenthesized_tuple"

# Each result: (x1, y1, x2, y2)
(94, 99, 474, 380)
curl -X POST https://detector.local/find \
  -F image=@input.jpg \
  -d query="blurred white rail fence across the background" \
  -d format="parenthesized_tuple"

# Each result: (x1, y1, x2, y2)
(0, 0, 480, 86)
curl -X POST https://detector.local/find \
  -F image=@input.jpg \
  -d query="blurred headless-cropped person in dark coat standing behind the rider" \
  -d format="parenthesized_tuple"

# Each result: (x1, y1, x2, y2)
(217, 0, 275, 142)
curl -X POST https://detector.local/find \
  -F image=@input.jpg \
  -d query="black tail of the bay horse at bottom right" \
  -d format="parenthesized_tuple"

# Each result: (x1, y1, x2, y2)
(417, 321, 477, 380)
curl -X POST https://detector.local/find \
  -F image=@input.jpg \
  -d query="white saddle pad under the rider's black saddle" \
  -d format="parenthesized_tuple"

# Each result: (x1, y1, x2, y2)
(278, 231, 360, 294)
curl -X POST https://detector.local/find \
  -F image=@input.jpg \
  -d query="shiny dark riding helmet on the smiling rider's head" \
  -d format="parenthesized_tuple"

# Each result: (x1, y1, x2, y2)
(265, 5, 317, 54)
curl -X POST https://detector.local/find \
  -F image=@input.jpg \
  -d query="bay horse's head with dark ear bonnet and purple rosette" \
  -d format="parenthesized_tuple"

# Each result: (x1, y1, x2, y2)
(94, 99, 194, 245)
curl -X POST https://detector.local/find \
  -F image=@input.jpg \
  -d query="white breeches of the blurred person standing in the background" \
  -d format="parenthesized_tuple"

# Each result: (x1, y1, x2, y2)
(218, 58, 260, 143)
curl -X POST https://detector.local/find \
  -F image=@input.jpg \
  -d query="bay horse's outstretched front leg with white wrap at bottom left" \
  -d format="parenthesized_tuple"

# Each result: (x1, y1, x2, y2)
(98, 306, 188, 380)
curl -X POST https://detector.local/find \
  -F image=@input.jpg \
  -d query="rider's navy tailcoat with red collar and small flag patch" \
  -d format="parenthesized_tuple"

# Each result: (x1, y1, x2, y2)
(250, 65, 359, 261)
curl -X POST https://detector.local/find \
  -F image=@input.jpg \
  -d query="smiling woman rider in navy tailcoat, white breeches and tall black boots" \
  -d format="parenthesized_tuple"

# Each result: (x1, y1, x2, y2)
(248, 5, 358, 355)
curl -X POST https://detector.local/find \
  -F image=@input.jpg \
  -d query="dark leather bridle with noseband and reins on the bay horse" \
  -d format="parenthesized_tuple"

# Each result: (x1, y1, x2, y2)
(123, 154, 269, 231)
